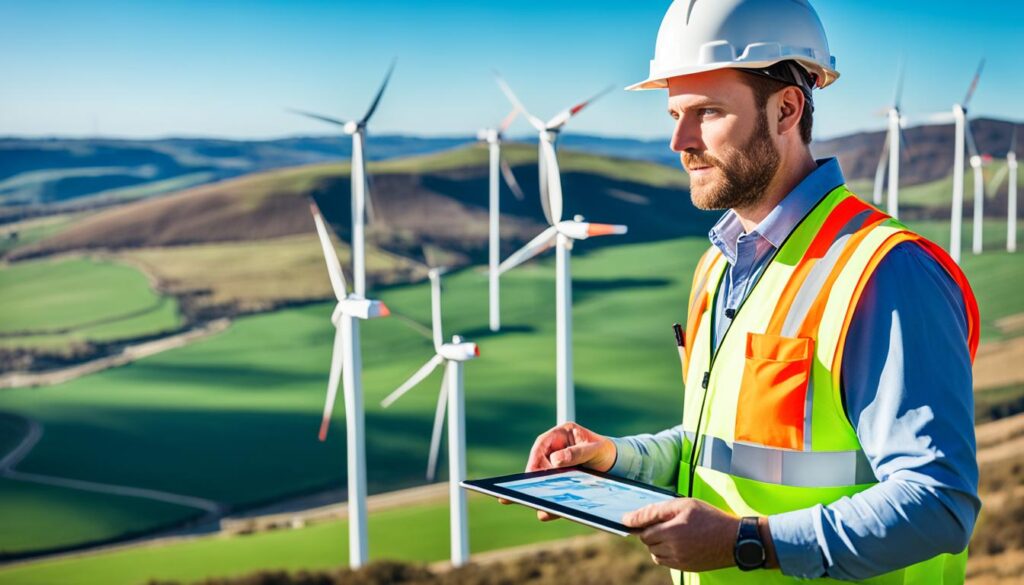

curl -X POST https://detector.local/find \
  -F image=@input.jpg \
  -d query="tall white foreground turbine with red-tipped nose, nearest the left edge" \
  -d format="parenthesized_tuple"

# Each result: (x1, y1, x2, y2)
(309, 203, 390, 568)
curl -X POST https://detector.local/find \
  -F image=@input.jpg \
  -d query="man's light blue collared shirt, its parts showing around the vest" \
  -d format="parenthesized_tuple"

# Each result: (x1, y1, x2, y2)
(611, 159, 981, 580)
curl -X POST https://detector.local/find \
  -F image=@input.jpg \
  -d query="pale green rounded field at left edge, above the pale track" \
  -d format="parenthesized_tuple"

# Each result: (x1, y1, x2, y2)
(0, 258, 179, 347)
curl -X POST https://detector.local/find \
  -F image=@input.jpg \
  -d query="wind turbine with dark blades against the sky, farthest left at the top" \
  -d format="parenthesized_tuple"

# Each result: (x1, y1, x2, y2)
(291, 61, 395, 295)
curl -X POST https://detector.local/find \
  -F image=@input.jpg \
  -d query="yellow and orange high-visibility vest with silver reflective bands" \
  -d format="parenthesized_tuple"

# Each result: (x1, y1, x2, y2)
(674, 186, 979, 584)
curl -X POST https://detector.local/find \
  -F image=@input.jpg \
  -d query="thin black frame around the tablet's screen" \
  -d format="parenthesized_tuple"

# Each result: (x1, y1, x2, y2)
(460, 466, 682, 536)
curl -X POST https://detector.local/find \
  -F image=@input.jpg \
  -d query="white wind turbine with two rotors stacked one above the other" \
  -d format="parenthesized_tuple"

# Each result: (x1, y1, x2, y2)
(498, 77, 627, 424)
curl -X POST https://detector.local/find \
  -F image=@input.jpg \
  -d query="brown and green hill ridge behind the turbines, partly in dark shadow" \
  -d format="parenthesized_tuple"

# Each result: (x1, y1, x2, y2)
(6, 144, 712, 268)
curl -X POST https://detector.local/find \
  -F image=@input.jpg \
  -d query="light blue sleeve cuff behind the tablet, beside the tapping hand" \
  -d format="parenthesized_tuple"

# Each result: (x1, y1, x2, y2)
(608, 425, 683, 491)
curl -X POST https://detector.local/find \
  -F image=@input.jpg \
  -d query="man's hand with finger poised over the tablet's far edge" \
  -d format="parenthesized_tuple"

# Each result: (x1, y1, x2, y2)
(499, 422, 615, 521)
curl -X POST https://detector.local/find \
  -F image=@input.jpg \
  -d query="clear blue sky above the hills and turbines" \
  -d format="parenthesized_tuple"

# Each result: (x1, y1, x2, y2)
(0, 0, 1024, 138)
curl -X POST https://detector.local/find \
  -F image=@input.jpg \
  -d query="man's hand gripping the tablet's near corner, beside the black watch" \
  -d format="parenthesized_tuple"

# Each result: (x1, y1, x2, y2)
(623, 498, 774, 572)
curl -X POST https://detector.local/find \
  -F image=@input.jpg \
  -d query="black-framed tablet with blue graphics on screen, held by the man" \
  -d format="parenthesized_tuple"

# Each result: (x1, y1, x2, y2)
(460, 467, 680, 536)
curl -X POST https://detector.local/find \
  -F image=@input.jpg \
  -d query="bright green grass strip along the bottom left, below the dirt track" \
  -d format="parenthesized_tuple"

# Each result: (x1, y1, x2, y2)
(0, 496, 592, 585)
